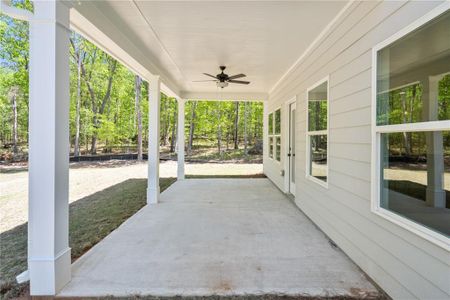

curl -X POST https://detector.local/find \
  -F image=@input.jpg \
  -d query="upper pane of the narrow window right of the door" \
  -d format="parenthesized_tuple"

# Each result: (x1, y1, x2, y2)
(308, 82, 328, 131)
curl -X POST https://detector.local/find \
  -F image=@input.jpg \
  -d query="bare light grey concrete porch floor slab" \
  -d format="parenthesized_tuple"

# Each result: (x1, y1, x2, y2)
(59, 179, 379, 298)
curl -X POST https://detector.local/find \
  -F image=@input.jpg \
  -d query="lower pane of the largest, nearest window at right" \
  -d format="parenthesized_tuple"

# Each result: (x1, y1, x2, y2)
(380, 131, 450, 236)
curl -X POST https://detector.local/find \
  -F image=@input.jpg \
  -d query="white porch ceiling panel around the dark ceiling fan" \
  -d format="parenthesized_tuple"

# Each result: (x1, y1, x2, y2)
(72, 0, 346, 95)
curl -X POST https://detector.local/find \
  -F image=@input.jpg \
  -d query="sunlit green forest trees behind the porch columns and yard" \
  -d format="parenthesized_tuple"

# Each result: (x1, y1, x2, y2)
(0, 1, 263, 161)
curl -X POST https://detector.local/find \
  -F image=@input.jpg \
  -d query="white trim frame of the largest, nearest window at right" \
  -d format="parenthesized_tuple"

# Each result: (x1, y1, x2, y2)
(371, 2, 450, 251)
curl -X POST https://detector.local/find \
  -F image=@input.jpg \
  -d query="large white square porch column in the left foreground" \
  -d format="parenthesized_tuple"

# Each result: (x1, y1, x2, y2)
(28, 1, 71, 295)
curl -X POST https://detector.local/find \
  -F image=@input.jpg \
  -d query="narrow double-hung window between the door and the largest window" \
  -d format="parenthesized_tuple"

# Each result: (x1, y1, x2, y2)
(306, 79, 328, 186)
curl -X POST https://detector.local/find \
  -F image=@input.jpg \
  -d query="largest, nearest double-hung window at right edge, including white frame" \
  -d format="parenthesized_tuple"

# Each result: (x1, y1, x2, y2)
(372, 11, 450, 245)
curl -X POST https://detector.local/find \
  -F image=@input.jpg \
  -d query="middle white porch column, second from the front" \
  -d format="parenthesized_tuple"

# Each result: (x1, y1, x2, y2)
(147, 76, 161, 204)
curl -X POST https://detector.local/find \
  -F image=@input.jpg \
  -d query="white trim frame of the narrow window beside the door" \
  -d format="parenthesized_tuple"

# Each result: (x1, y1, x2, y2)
(305, 75, 330, 189)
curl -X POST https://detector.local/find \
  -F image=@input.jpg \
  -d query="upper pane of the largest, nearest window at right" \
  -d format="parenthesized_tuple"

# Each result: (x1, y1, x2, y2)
(377, 12, 450, 125)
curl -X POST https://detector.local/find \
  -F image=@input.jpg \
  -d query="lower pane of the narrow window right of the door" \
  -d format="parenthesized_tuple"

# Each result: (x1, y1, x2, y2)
(309, 135, 328, 182)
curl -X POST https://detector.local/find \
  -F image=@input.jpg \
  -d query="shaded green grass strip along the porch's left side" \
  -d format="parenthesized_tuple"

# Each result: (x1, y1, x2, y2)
(0, 178, 176, 299)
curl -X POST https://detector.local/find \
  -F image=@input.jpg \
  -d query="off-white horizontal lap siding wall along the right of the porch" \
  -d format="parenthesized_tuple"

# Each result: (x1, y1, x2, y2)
(264, 1, 450, 299)
